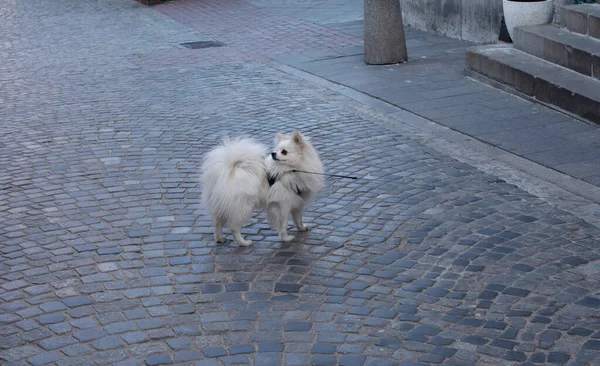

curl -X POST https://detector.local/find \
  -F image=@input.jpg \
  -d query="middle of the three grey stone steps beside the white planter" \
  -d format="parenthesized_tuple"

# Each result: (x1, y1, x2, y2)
(513, 24, 600, 79)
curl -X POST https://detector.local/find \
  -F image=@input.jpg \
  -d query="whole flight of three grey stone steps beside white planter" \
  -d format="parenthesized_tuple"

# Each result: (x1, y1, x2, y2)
(466, 4, 600, 123)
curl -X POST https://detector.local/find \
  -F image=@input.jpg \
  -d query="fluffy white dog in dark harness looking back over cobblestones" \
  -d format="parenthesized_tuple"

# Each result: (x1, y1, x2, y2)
(202, 131, 323, 246)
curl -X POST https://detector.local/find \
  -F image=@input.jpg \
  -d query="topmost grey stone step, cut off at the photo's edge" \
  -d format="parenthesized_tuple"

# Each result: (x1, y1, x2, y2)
(560, 4, 600, 38)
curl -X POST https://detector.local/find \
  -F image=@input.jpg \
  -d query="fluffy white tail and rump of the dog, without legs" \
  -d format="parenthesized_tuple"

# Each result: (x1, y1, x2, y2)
(202, 138, 268, 227)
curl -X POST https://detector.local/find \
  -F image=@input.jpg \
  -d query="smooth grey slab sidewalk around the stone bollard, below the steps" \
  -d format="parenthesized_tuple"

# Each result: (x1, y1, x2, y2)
(276, 21, 600, 186)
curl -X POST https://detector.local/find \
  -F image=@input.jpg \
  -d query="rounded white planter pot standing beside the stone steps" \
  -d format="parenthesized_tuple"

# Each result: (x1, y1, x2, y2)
(502, 0, 554, 38)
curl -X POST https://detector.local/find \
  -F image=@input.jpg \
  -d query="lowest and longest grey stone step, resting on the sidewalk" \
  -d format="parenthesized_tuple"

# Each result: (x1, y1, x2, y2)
(466, 44, 600, 124)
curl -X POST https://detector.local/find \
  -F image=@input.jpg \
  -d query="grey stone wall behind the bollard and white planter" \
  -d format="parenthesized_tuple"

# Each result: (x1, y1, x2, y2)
(401, 0, 572, 43)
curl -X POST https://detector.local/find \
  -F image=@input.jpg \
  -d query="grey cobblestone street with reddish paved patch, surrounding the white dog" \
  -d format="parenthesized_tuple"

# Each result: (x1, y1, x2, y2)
(0, 0, 600, 366)
